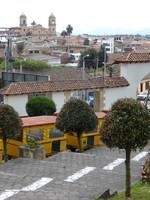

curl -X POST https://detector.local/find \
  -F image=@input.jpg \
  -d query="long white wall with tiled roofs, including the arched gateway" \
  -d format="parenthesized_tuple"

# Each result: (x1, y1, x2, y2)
(0, 52, 150, 115)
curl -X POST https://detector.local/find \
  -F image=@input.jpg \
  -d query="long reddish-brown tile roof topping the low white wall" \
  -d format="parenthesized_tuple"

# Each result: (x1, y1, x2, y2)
(0, 77, 129, 95)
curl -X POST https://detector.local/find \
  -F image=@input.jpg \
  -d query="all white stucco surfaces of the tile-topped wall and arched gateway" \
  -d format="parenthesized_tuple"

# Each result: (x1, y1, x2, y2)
(4, 63, 150, 116)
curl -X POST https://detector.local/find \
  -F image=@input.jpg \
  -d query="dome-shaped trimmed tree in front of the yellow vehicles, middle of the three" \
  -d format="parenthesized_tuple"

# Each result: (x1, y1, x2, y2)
(56, 98, 98, 152)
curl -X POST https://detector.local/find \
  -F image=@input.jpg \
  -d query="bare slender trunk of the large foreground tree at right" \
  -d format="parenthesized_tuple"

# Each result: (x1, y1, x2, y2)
(125, 148, 131, 199)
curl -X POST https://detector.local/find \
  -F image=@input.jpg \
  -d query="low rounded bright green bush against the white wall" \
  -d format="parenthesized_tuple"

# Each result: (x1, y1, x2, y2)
(26, 96, 56, 116)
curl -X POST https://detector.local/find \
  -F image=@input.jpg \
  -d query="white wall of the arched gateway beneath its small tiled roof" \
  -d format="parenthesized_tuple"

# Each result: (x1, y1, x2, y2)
(120, 63, 150, 98)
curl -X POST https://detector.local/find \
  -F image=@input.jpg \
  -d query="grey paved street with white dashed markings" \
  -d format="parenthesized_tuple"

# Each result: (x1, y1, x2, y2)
(0, 146, 148, 200)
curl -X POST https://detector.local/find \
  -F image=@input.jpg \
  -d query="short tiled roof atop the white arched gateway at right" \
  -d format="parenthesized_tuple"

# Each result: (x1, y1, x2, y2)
(115, 52, 150, 63)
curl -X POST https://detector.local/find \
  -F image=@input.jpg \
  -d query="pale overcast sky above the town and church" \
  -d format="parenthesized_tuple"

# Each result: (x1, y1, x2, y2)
(0, 0, 150, 34)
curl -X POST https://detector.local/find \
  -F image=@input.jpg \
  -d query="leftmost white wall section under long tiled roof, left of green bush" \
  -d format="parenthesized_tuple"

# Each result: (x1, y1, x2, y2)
(4, 95, 28, 116)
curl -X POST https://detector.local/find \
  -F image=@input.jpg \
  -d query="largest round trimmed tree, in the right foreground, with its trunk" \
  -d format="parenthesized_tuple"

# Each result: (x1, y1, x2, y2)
(100, 98, 150, 198)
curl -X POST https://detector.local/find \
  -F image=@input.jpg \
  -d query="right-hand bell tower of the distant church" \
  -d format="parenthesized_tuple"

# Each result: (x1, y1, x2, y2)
(48, 13, 56, 38)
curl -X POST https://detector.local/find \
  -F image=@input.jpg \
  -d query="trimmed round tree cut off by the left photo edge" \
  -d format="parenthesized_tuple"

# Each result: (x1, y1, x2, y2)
(0, 104, 22, 162)
